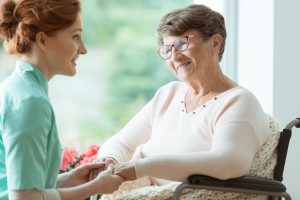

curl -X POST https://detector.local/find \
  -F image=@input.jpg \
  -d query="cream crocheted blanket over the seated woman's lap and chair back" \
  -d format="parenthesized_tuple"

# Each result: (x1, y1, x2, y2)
(101, 117, 279, 200)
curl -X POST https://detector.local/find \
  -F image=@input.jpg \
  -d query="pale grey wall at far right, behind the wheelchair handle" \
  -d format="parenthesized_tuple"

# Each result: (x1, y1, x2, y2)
(273, 0, 300, 199)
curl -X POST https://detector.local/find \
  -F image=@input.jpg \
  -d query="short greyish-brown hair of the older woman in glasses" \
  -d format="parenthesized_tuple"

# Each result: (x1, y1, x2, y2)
(157, 4, 226, 61)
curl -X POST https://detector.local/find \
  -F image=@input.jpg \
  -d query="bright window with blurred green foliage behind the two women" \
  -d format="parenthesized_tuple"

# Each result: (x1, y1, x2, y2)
(0, 0, 235, 149)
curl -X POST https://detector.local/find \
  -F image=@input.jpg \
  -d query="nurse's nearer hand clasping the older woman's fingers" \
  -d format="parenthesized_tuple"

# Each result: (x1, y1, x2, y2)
(95, 165, 124, 194)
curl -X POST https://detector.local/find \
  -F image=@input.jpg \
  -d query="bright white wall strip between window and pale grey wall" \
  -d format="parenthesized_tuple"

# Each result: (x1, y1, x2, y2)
(237, 0, 273, 114)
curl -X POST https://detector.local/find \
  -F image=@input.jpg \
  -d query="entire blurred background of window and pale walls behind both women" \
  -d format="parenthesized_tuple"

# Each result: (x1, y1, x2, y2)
(0, 0, 300, 199)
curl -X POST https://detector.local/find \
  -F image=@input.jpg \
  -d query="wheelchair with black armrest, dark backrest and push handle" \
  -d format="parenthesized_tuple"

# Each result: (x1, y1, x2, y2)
(173, 118, 300, 200)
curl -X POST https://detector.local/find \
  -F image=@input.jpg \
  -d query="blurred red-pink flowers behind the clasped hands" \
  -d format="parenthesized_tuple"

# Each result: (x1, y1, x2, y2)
(60, 145, 100, 173)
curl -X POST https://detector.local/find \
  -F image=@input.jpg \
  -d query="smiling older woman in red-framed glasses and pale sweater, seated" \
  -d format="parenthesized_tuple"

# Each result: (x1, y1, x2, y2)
(98, 5, 278, 199)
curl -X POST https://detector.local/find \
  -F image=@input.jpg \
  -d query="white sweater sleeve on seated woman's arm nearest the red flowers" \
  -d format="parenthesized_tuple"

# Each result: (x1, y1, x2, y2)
(97, 101, 152, 163)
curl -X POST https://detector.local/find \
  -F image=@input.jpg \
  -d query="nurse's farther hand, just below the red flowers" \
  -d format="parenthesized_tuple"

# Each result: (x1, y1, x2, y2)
(57, 162, 105, 188)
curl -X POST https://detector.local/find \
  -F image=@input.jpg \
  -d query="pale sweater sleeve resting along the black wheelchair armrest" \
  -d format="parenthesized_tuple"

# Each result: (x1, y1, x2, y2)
(135, 92, 268, 181)
